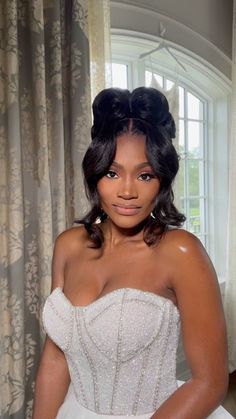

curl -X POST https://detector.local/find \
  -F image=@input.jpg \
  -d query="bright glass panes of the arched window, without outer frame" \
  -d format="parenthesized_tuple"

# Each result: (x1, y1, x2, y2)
(112, 63, 208, 246)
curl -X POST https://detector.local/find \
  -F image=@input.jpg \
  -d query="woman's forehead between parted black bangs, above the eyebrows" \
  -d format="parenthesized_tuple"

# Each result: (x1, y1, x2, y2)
(114, 133, 147, 165)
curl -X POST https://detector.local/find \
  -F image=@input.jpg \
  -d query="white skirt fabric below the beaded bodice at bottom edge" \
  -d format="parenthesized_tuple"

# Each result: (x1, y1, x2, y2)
(56, 382, 233, 419)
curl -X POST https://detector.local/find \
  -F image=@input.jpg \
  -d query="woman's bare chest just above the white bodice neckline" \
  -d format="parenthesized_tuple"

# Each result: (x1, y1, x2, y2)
(64, 244, 172, 304)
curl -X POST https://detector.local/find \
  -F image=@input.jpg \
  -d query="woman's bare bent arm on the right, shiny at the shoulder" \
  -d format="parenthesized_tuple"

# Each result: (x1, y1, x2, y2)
(152, 231, 228, 419)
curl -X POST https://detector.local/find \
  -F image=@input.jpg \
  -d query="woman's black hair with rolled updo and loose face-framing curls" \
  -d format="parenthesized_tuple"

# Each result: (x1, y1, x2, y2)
(76, 87, 185, 247)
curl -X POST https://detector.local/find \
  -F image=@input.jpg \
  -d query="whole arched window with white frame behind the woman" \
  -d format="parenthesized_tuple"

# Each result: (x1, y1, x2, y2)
(112, 37, 231, 282)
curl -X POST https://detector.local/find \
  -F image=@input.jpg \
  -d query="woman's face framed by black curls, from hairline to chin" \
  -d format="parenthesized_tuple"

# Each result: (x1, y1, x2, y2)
(97, 133, 160, 228)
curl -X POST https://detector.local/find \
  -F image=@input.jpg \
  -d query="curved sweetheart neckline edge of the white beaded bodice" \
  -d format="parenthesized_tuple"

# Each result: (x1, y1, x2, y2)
(52, 287, 179, 313)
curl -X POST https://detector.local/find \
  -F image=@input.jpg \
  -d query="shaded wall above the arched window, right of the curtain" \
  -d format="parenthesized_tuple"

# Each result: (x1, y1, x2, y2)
(111, 0, 233, 78)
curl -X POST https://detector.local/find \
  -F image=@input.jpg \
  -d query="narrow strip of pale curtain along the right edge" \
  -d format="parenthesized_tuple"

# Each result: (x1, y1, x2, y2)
(224, 0, 236, 372)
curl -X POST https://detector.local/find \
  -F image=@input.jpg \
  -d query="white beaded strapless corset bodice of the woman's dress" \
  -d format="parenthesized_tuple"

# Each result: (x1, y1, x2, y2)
(43, 288, 179, 415)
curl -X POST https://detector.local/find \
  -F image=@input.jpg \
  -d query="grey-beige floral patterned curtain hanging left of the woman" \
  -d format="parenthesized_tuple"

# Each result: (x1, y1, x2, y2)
(0, 0, 109, 419)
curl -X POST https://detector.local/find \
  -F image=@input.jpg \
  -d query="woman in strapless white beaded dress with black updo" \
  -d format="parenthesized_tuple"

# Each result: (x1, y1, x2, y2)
(33, 87, 228, 419)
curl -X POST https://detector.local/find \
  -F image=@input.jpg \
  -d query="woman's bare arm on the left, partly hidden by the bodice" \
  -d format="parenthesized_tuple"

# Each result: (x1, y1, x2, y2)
(33, 233, 70, 419)
